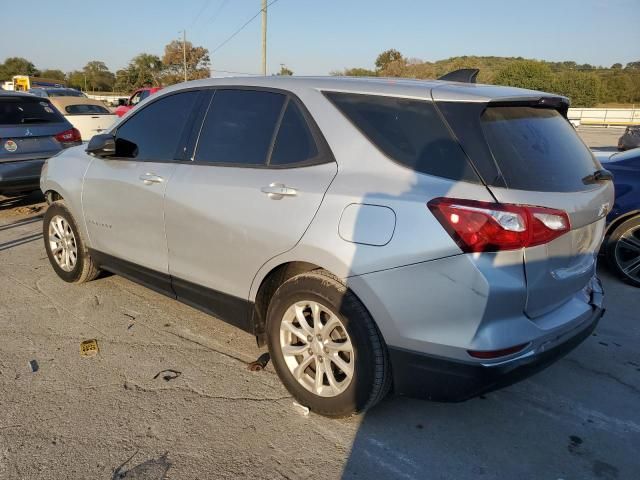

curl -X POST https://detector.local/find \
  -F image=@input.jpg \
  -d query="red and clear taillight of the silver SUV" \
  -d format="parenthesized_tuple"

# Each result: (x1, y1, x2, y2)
(427, 198, 571, 253)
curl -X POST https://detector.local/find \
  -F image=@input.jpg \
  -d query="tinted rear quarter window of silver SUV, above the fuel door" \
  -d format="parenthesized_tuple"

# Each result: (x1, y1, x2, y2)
(325, 92, 479, 183)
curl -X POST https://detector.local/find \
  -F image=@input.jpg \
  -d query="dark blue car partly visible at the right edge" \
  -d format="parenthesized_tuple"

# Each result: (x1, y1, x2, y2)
(602, 148, 640, 287)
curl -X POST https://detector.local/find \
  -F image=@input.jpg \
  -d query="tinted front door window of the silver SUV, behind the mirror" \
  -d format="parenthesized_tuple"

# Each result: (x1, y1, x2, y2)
(116, 91, 199, 161)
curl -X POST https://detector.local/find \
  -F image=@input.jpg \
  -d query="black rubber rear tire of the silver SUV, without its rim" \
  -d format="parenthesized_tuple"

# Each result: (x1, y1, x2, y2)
(267, 270, 391, 417)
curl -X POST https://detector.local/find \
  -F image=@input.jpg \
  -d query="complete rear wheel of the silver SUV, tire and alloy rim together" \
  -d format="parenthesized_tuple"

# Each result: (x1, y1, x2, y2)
(267, 270, 391, 417)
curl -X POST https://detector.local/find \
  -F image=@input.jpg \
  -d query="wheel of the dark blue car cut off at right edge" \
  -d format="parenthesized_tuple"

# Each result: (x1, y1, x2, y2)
(606, 216, 640, 287)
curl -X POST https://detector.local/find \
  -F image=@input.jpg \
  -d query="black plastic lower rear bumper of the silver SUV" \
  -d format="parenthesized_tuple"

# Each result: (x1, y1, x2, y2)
(389, 300, 604, 402)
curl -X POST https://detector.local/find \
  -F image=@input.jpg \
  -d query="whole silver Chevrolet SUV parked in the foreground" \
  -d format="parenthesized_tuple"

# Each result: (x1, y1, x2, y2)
(41, 78, 613, 416)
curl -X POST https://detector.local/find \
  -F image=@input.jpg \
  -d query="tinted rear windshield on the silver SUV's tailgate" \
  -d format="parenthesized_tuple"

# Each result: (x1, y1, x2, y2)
(480, 106, 597, 192)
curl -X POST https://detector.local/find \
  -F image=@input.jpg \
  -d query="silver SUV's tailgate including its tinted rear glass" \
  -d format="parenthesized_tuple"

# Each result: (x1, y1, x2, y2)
(441, 99, 614, 318)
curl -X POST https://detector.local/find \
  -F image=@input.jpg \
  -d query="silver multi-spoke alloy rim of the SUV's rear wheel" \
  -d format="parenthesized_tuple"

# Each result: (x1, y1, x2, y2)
(280, 301, 355, 397)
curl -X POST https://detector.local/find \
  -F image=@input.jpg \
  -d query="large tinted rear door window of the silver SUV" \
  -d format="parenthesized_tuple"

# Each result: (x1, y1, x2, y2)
(195, 90, 286, 166)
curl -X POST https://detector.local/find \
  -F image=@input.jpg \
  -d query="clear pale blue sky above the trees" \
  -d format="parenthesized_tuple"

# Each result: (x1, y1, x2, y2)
(0, 0, 640, 75)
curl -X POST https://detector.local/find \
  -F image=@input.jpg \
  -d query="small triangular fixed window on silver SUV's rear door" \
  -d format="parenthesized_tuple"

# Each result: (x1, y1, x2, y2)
(269, 100, 318, 165)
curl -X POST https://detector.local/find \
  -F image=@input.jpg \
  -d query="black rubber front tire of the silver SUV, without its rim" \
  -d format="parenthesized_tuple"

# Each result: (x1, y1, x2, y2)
(42, 200, 100, 283)
